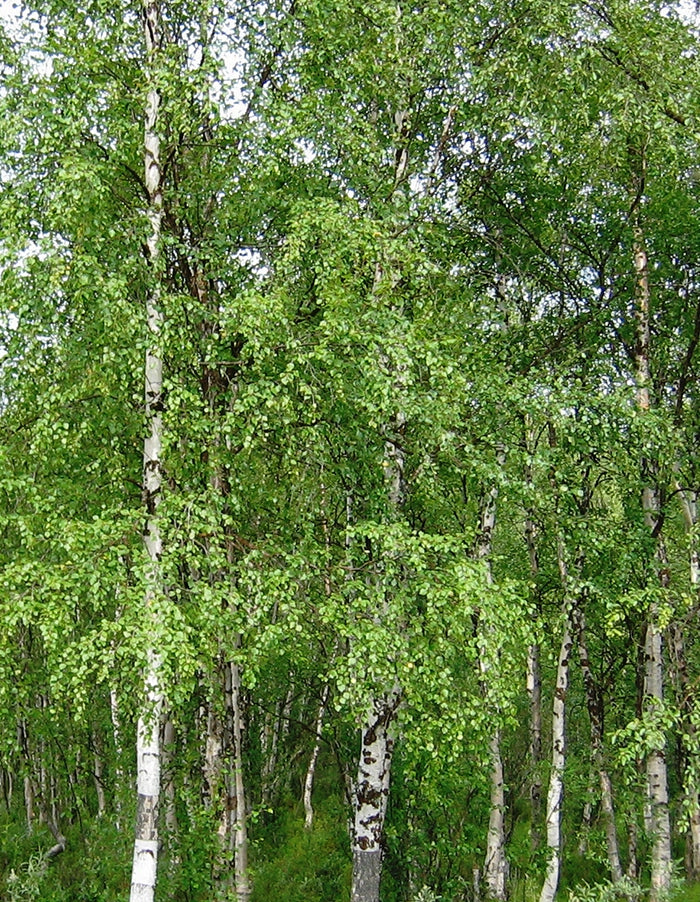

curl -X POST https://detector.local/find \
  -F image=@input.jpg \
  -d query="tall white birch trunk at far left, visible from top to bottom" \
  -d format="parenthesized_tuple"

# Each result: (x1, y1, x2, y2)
(129, 0, 163, 902)
